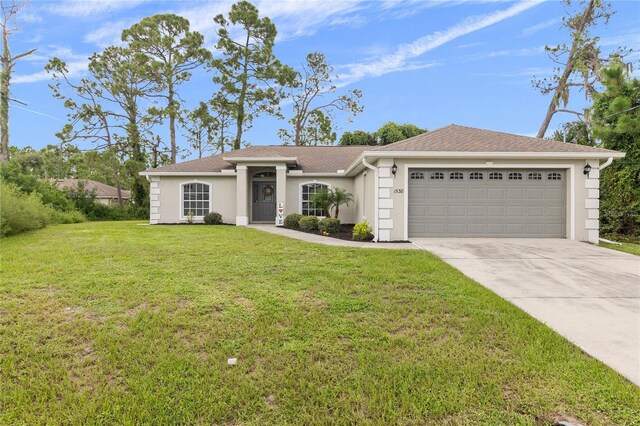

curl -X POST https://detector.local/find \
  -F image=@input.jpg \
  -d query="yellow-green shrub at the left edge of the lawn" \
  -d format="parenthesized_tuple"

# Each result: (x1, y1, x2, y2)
(0, 180, 52, 237)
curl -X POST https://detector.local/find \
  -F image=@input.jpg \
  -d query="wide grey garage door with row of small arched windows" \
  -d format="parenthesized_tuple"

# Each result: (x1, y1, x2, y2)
(408, 169, 566, 238)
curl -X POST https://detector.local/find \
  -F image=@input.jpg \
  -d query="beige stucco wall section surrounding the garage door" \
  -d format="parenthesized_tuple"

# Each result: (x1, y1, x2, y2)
(375, 159, 599, 242)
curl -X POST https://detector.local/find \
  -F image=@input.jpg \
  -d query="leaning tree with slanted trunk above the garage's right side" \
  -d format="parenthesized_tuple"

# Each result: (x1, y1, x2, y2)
(533, 0, 623, 138)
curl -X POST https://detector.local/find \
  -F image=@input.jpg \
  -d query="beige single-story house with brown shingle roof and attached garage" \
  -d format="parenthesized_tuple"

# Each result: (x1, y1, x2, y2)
(141, 125, 624, 242)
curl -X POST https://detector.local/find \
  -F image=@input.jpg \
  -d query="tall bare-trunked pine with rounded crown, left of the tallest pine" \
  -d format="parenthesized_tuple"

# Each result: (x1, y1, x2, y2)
(122, 14, 211, 164)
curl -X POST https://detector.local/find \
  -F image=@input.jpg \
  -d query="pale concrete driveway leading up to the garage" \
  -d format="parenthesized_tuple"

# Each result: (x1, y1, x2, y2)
(412, 238, 640, 385)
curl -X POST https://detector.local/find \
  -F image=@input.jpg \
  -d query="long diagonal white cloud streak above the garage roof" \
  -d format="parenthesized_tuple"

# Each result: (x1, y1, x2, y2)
(341, 0, 541, 85)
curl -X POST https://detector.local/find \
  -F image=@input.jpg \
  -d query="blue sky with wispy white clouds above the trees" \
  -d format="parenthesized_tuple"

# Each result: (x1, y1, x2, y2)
(10, 0, 640, 157)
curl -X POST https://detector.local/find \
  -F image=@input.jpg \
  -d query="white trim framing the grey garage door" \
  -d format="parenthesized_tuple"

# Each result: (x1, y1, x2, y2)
(403, 162, 576, 241)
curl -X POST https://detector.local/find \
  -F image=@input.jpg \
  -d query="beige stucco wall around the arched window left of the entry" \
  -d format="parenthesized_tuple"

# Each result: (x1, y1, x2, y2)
(151, 176, 236, 223)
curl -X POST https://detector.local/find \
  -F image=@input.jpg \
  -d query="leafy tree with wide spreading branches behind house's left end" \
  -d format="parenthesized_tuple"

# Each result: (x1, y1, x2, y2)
(46, 46, 158, 205)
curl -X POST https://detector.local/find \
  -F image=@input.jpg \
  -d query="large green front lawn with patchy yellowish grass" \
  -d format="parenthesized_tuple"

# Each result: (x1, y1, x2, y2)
(0, 222, 640, 425)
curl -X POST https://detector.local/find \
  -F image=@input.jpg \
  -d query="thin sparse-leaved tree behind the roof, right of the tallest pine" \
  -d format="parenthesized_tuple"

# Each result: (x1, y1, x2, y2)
(279, 52, 363, 145)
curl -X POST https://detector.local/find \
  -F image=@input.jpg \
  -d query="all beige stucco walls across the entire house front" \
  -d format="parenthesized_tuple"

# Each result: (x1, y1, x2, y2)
(150, 159, 599, 242)
